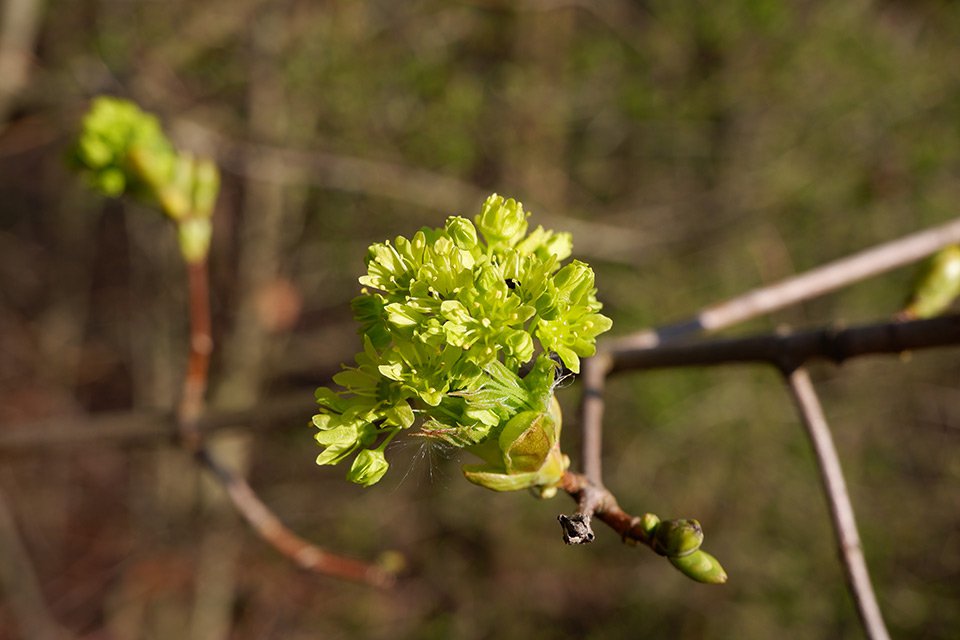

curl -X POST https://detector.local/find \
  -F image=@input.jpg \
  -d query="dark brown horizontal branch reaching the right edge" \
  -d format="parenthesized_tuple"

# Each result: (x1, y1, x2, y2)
(604, 314, 960, 373)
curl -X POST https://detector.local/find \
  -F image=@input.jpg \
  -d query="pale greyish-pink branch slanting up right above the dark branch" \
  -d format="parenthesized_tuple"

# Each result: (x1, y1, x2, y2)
(598, 215, 960, 351)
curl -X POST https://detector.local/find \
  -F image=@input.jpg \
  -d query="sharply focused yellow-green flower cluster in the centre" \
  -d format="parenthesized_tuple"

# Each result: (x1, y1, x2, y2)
(314, 195, 611, 485)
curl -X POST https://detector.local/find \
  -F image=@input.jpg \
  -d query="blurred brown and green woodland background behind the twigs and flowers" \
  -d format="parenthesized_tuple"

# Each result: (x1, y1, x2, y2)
(0, 0, 960, 640)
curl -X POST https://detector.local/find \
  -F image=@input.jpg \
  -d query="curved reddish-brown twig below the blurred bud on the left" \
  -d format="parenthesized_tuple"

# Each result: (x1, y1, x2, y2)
(177, 255, 394, 587)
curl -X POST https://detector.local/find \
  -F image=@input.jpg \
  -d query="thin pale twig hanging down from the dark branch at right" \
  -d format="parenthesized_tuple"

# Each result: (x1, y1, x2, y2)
(783, 368, 890, 640)
